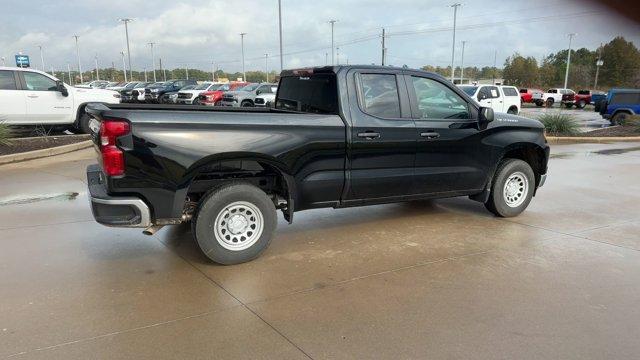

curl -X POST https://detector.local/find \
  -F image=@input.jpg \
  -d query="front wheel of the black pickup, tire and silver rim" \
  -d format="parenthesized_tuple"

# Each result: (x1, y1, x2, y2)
(484, 159, 536, 217)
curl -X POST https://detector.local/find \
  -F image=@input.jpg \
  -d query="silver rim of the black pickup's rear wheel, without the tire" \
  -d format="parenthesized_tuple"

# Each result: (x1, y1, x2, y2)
(215, 201, 264, 251)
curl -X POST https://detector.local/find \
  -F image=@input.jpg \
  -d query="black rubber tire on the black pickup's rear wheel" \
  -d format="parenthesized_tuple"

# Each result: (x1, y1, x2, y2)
(191, 183, 277, 265)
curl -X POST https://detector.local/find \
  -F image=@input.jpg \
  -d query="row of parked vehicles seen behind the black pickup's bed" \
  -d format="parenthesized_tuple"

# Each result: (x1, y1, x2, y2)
(94, 79, 278, 107)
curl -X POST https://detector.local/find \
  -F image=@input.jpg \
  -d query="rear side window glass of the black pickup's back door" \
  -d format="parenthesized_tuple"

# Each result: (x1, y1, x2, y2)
(360, 74, 400, 118)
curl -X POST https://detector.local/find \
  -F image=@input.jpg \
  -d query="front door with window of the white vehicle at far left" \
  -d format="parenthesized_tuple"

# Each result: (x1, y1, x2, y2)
(20, 71, 75, 124)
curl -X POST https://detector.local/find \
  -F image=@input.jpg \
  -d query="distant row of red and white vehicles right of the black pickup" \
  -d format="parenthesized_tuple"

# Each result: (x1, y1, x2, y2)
(520, 88, 607, 109)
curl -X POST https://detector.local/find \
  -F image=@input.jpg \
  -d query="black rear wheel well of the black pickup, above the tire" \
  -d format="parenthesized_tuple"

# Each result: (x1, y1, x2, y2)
(185, 159, 293, 221)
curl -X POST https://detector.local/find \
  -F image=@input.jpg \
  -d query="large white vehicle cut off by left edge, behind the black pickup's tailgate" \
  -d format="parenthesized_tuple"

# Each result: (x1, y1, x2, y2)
(0, 67, 120, 133)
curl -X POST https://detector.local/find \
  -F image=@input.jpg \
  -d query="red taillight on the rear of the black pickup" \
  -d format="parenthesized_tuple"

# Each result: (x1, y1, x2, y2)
(100, 120, 131, 176)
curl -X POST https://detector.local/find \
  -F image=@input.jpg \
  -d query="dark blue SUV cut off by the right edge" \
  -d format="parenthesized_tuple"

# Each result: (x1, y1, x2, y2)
(595, 89, 640, 125)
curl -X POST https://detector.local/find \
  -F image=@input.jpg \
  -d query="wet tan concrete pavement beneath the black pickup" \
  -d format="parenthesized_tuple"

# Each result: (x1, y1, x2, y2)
(0, 143, 640, 359)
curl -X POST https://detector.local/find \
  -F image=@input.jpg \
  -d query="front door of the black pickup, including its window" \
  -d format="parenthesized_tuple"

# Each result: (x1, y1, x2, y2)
(406, 74, 487, 194)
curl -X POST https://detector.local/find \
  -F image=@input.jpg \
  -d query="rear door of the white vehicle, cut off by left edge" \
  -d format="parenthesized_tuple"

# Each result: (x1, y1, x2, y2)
(0, 70, 27, 124)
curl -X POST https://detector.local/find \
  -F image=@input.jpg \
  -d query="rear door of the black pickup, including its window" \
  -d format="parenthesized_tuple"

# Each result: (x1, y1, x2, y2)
(347, 69, 417, 203)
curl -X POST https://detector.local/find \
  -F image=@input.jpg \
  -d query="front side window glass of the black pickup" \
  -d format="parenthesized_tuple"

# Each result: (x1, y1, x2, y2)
(412, 77, 468, 119)
